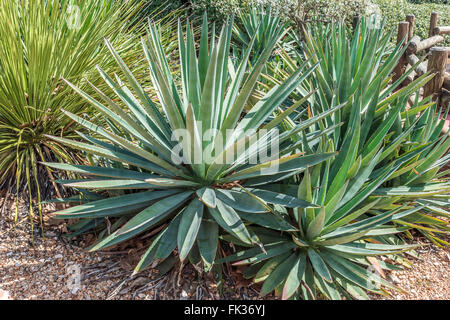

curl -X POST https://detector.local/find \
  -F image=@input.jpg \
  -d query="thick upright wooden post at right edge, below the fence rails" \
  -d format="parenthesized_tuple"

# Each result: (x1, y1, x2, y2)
(423, 47, 448, 97)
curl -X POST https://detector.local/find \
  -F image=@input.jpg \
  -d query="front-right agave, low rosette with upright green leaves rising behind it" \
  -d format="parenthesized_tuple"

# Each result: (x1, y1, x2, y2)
(223, 72, 423, 299)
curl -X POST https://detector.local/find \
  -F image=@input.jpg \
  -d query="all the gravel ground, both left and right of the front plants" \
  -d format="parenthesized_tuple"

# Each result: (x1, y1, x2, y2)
(0, 195, 450, 300)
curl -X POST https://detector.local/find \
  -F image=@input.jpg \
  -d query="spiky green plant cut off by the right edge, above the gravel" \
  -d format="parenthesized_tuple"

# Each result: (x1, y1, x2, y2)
(374, 101, 450, 247)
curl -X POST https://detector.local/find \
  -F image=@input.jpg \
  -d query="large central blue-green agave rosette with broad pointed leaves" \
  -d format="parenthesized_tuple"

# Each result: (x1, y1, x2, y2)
(47, 16, 339, 271)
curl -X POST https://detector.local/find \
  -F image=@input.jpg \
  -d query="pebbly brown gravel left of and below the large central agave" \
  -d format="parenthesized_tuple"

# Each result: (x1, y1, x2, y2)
(0, 198, 274, 300)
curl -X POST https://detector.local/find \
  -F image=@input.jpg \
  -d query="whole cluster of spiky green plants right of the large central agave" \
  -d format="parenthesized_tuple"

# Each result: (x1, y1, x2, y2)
(221, 20, 450, 299)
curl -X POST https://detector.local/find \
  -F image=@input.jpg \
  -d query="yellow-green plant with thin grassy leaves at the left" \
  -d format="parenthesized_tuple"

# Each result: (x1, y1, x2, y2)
(0, 0, 146, 235)
